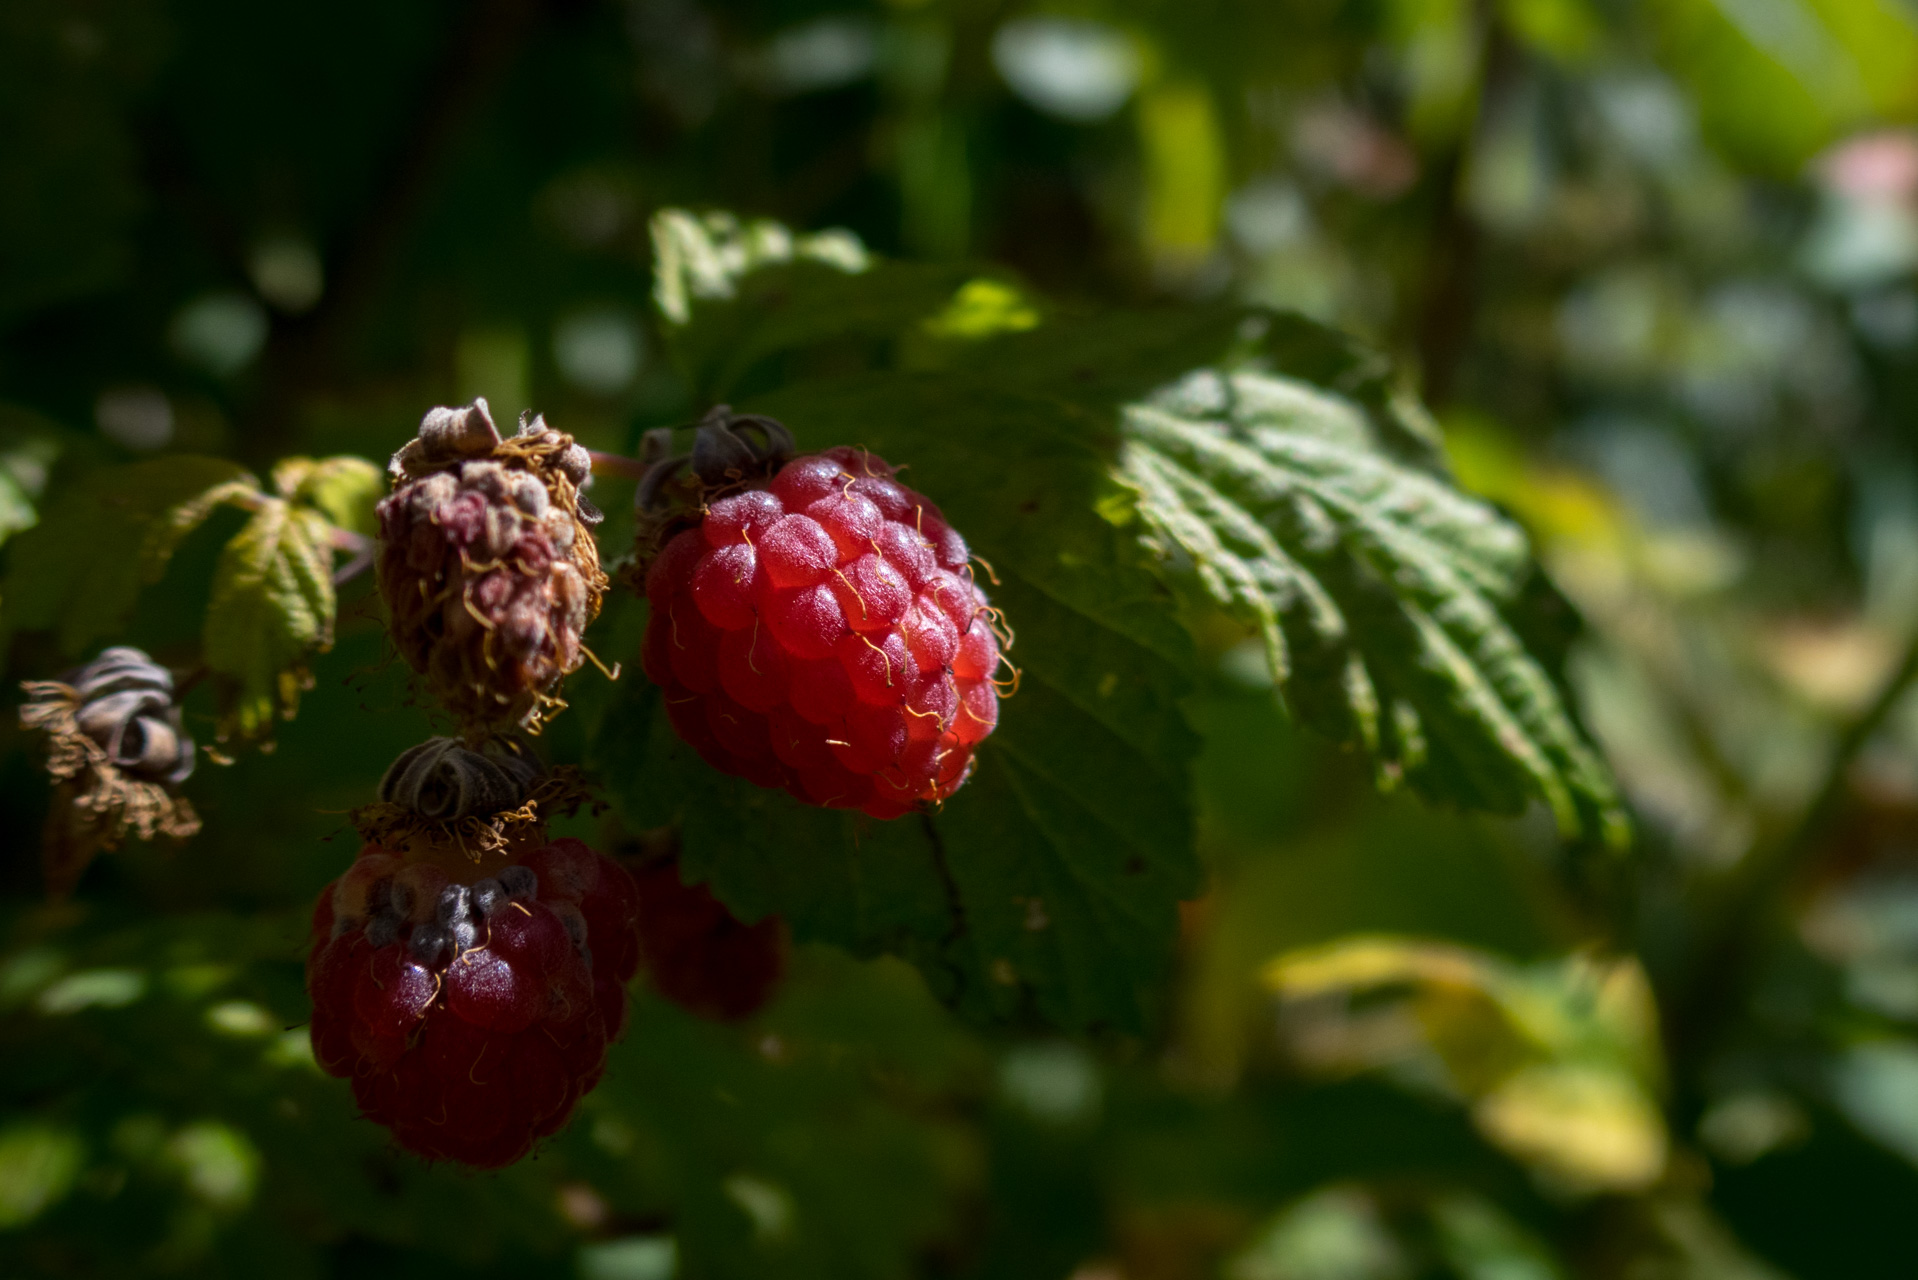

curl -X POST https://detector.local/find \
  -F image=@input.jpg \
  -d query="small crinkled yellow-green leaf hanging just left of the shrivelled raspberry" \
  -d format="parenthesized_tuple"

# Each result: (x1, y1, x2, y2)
(201, 497, 334, 741)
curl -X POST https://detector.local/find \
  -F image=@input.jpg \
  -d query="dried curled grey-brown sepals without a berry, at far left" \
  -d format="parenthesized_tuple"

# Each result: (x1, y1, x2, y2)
(19, 647, 199, 898)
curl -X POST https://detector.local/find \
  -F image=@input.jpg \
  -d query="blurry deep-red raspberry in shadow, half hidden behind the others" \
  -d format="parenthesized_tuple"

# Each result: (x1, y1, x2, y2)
(633, 862, 786, 1021)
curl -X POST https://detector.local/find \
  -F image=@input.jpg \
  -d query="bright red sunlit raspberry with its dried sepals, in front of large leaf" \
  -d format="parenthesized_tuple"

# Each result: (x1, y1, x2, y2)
(635, 405, 1011, 818)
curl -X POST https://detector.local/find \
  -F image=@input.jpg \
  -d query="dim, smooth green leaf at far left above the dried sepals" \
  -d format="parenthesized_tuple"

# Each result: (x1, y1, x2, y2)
(0, 455, 259, 654)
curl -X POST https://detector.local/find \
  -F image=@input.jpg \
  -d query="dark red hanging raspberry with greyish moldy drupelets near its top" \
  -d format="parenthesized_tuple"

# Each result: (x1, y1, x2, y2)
(307, 841, 639, 1169)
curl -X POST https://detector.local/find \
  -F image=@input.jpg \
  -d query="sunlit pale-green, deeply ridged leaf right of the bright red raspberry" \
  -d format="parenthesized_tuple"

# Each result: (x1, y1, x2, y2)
(1118, 364, 1626, 842)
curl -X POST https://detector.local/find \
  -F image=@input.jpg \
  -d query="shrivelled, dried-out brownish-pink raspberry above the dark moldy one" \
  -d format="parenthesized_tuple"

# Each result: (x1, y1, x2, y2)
(380, 399, 606, 733)
